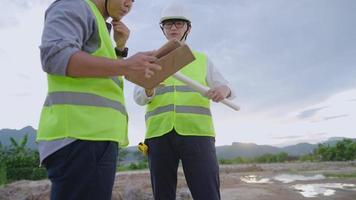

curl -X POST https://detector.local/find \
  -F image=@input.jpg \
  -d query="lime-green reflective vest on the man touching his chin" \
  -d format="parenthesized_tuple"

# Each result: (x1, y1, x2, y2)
(37, 0, 128, 146)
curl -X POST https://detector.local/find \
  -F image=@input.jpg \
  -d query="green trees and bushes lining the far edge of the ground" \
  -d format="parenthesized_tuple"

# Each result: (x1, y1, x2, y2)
(0, 135, 356, 185)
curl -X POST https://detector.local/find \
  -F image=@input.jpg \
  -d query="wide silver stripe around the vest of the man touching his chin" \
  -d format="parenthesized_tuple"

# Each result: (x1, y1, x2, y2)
(44, 92, 127, 116)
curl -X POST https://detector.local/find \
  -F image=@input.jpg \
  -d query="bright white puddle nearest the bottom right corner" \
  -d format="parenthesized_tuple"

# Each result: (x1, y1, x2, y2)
(292, 183, 355, 198)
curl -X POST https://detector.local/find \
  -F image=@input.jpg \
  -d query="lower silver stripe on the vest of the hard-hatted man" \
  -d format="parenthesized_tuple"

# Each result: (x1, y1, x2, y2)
(145, 104, 211, 120)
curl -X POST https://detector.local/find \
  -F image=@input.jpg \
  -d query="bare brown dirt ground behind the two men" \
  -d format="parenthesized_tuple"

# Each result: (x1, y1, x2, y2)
(0, 162, 356, 200)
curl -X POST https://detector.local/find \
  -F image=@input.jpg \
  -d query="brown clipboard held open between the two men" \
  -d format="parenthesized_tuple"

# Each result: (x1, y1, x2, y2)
(125, 40, 195, 89)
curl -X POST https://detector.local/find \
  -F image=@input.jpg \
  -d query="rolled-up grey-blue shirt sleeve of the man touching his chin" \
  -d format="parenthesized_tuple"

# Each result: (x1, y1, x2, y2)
(39, 1, 93, 76)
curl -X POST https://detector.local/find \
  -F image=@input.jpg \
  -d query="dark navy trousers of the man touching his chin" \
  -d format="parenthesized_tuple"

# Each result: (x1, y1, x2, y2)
(43, 140, 118, 200)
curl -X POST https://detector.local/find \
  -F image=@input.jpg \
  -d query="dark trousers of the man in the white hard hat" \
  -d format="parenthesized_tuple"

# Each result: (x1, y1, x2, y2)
(145, 130, 220, 200)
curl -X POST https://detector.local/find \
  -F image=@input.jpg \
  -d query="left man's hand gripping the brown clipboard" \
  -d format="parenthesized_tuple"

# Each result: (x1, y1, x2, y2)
(120, 51, 162, 78)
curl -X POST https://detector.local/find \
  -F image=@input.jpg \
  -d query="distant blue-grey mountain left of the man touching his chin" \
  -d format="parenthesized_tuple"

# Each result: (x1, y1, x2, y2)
(0, 126, 37, 149)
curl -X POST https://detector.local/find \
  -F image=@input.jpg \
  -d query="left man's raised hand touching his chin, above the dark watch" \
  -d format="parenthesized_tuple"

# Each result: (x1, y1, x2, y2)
(111, 20, 130, 50)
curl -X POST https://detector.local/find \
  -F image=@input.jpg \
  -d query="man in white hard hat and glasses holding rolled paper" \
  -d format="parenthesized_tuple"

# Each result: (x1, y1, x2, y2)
(134, 2, 234, 200)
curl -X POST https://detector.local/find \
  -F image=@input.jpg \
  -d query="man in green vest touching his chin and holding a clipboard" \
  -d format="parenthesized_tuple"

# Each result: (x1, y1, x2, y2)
(37, 0, 161, 200)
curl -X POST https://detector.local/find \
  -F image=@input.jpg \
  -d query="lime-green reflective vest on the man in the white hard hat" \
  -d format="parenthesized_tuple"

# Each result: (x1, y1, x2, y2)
(145, 52, 215, 138)
